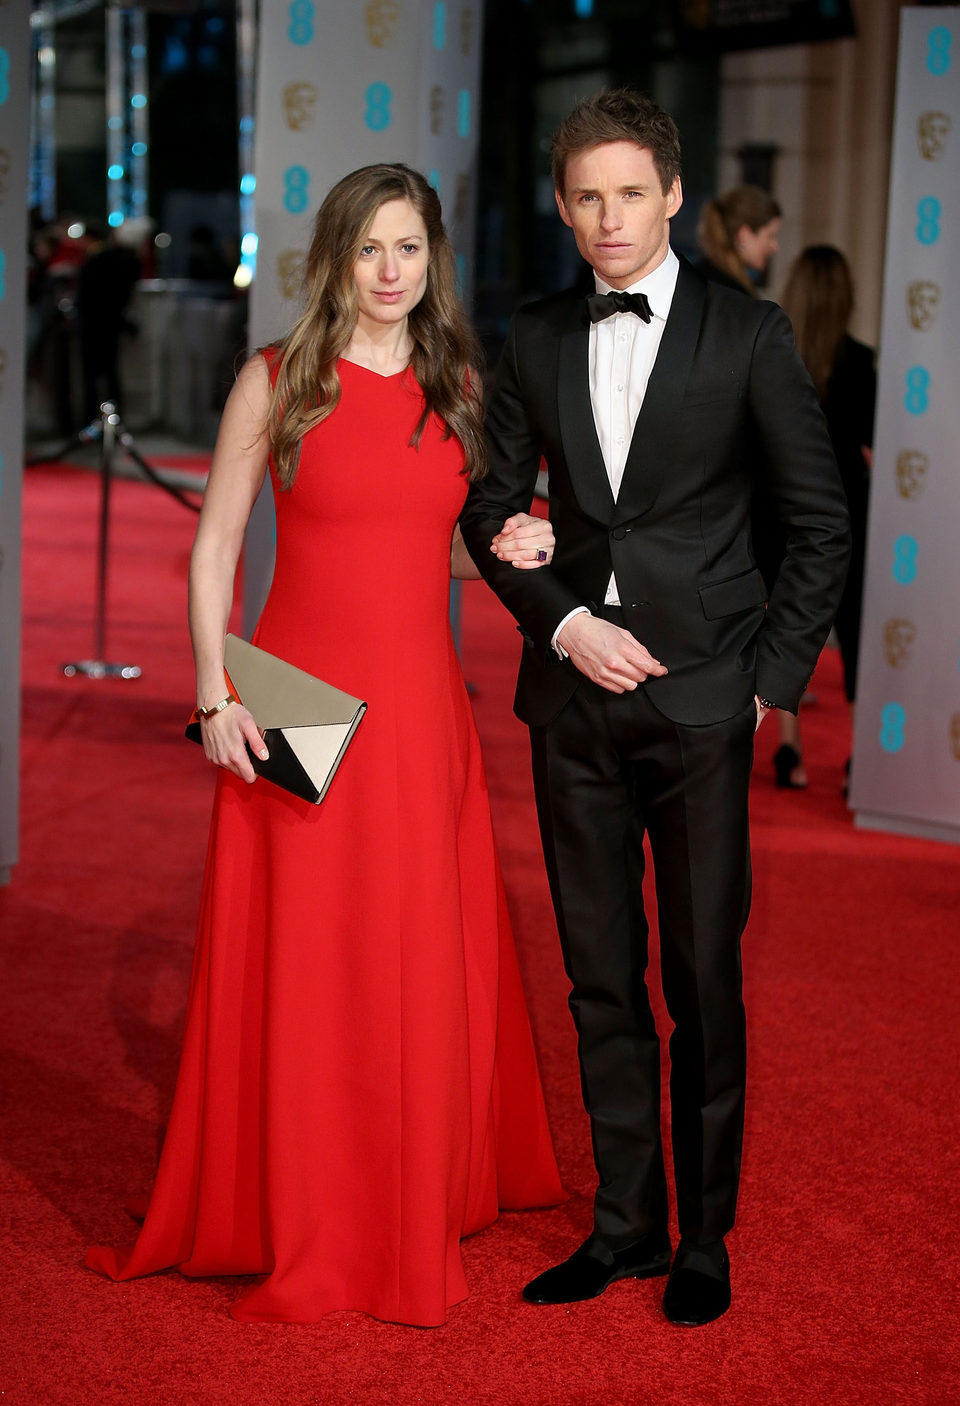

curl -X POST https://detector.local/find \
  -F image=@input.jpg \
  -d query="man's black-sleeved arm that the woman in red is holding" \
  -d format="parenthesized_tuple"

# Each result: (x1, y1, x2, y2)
(460, 318, 583, 658)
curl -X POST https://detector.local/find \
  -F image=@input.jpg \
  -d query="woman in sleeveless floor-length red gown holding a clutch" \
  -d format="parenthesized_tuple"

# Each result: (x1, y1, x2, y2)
(87, 166, 564, 1326)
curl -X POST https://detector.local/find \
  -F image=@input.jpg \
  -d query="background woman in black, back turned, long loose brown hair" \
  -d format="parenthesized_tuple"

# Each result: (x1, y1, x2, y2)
(773, 245, 877, 789)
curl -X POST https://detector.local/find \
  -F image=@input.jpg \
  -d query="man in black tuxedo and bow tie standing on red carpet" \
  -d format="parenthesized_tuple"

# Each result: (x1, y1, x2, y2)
(461, 90, 848, 1323)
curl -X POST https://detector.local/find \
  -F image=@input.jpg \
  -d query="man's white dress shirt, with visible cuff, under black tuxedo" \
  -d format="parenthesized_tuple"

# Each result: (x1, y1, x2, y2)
(552, 247, 680, 657)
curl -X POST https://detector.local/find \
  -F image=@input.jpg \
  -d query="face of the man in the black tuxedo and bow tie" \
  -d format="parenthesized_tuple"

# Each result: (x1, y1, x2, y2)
(557, 142, 683, 288)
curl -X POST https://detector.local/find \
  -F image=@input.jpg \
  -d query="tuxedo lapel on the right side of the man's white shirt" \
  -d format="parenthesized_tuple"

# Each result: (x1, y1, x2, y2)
(615, 259, 706, 522)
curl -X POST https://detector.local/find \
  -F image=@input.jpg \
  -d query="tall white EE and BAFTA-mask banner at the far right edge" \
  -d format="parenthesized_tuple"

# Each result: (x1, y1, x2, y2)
(850, 6, 960, 842)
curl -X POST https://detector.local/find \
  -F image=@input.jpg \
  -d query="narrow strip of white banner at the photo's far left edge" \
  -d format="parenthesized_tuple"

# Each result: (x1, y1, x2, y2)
(0, 3, 31, 884)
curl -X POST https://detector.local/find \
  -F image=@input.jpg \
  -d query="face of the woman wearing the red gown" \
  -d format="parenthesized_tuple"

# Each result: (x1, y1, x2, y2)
(353, 200, 430, 332)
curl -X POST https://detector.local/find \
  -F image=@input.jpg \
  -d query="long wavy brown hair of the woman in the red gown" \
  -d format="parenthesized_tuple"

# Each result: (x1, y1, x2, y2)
(267, 163, 486, 489)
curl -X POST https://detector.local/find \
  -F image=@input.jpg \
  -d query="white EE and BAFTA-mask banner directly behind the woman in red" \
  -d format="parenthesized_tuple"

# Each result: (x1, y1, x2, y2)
(243, 0, 484, 633)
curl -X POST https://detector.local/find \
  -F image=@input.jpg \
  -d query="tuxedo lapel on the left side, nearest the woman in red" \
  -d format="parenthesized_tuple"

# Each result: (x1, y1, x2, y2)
(557, 298, 614, 524)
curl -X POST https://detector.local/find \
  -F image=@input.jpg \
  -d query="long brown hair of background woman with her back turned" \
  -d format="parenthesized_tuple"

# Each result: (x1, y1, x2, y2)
(781, 245, 853, 401)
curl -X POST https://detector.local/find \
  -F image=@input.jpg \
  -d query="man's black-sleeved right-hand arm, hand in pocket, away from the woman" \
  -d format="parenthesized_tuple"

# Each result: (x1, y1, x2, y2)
(749, 305, 850, 711)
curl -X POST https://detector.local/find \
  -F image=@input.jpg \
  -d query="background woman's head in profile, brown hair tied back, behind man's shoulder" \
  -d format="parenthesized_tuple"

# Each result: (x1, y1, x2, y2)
(697, 186, 780, 294)
